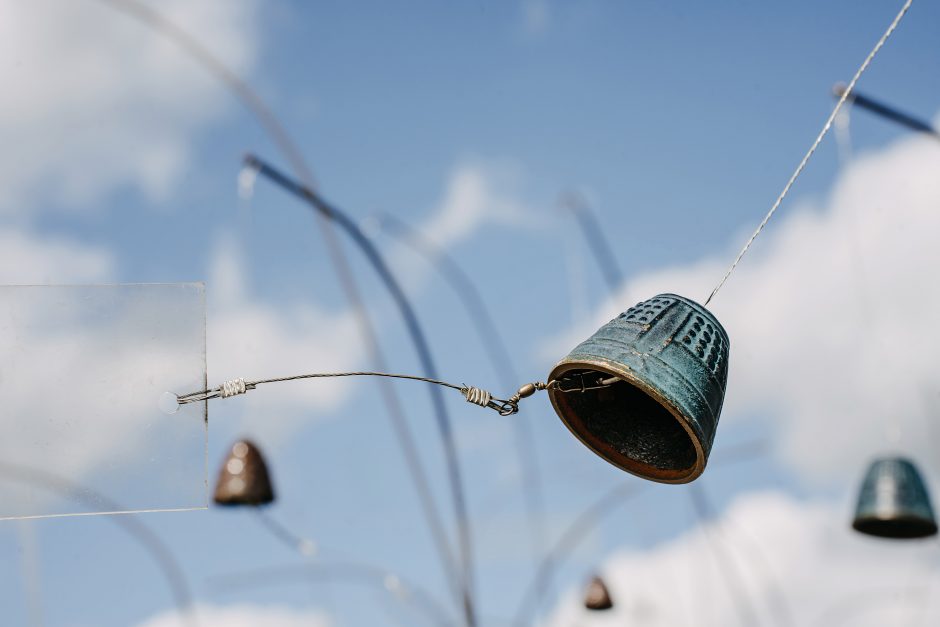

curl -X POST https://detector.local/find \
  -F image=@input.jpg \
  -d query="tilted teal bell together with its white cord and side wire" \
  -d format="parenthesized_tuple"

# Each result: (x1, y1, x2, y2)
(167, 0, 911, 490)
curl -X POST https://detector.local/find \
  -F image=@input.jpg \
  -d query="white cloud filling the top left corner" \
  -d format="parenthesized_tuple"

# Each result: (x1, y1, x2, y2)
(0, 0, 257, 212)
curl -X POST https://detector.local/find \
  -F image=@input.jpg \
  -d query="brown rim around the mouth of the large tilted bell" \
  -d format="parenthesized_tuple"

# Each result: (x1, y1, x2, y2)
(548, 358, 708, 485)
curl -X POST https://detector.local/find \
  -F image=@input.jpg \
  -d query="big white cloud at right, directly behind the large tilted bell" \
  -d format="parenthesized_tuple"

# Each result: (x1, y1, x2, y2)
(552, 132, 940, 480)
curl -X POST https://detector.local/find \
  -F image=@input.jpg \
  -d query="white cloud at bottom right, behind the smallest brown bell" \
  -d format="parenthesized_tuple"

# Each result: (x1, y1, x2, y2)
(548, 492, 940, 627)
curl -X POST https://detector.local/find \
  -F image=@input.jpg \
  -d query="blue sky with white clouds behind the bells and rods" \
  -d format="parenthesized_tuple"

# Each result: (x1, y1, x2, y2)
(0, 0, 940, 627)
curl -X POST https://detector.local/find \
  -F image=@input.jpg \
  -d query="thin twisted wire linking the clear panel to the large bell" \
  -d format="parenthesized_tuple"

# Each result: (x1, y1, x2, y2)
(176, 372, 555, 416)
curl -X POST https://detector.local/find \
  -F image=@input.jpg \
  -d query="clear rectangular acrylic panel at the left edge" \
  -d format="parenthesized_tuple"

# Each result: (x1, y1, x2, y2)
(0, 283, 208, 519)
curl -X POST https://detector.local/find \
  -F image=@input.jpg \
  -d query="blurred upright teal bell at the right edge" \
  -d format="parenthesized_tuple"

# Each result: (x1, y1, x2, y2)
(852, 457, 937, 539)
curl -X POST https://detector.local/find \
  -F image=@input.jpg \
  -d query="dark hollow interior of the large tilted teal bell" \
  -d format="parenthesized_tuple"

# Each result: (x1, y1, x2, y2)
(556, 370, 698, 482)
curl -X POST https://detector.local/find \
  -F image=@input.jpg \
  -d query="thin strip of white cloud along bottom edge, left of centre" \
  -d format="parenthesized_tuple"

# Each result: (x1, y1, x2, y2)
(138, 604, 333, 627)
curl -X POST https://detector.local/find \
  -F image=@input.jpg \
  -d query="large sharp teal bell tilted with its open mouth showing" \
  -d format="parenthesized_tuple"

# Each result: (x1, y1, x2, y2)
(548, 294, 729, 483)
